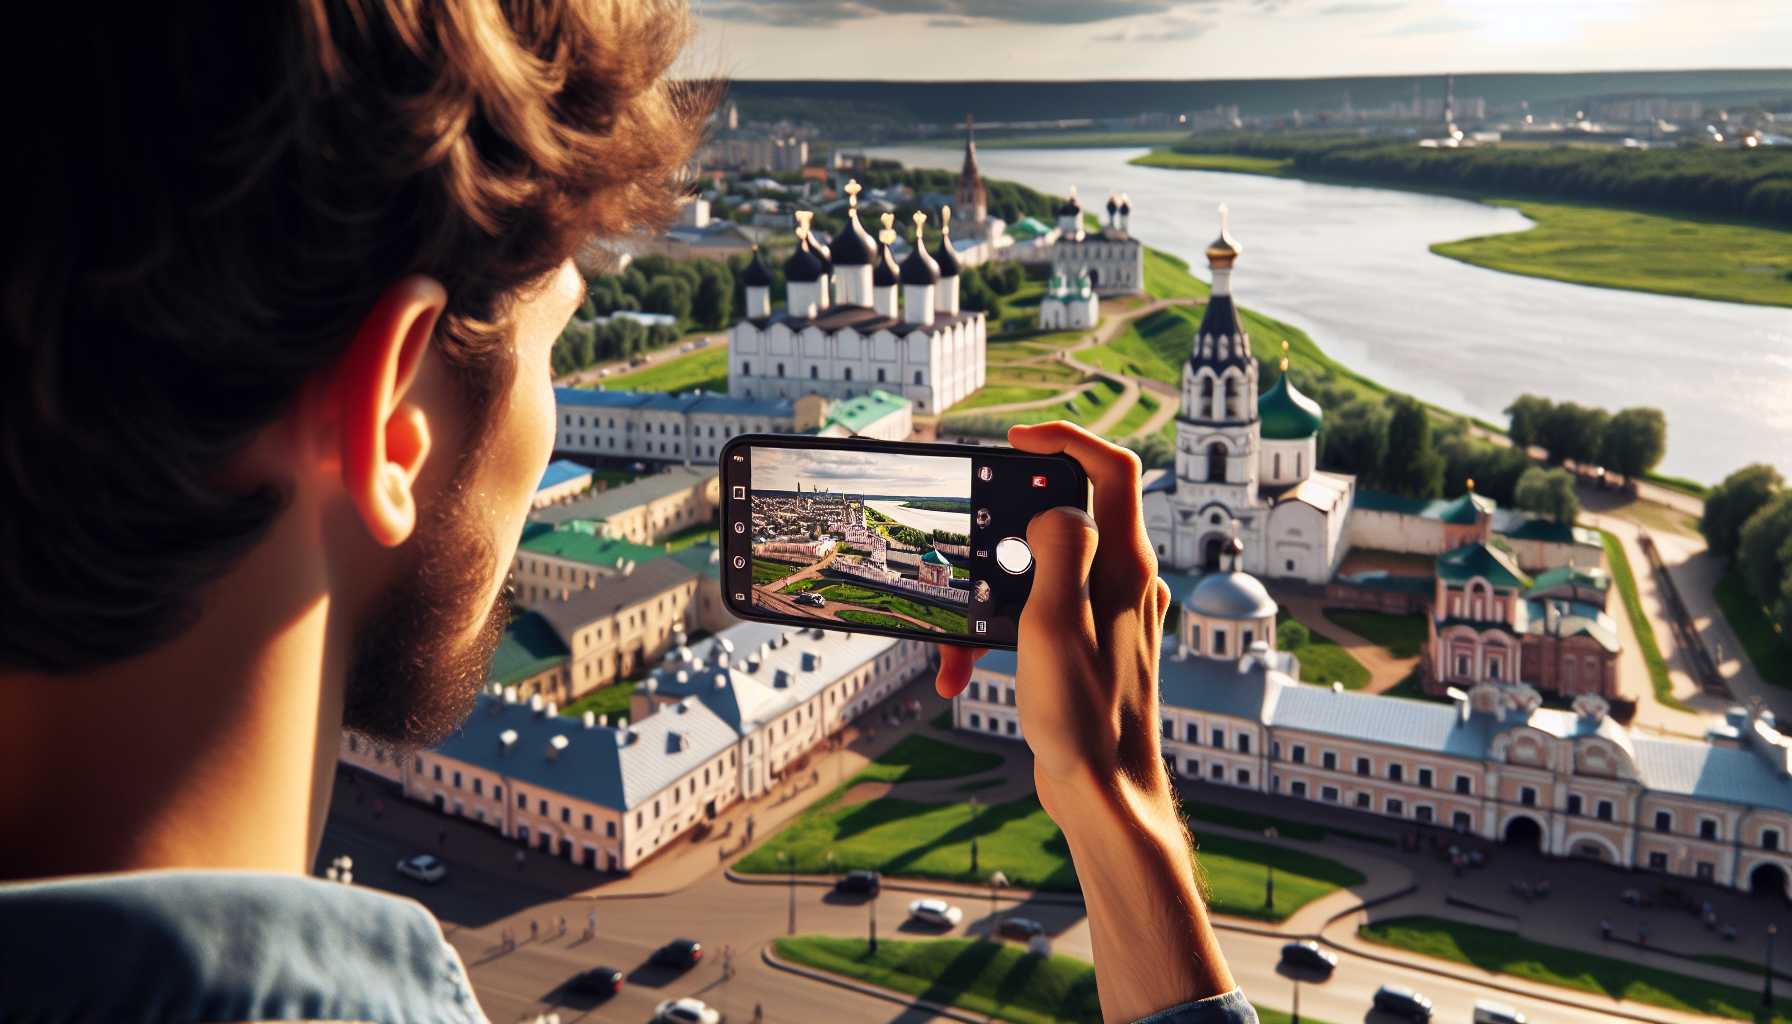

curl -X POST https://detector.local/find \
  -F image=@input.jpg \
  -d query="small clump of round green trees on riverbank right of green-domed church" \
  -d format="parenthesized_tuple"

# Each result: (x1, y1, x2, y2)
(1505, 395, 1668, 477)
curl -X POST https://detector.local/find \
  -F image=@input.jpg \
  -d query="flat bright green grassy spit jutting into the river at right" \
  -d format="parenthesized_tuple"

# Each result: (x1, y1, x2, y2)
(1432, 199, 1792, 307)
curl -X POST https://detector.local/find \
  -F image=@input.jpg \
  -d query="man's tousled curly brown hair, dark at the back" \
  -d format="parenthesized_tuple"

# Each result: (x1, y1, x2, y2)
(0, 0, 720, 671)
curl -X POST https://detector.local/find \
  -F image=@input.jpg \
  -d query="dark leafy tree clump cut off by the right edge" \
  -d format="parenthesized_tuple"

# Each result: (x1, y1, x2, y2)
(1699, 464, 1792, 649)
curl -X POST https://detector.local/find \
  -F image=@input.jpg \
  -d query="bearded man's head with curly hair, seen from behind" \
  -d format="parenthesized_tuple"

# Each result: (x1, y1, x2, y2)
(0, 0, 715, 744)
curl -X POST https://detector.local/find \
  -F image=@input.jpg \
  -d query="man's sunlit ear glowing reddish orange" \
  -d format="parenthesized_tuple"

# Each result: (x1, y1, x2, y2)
(335, 274, 448, 547)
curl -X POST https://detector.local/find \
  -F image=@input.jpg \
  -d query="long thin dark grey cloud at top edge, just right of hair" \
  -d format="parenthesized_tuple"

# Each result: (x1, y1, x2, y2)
(697, 0, 1179, 27)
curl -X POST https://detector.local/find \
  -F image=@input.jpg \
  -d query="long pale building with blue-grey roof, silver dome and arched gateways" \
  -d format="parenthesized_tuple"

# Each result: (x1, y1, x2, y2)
(953, 545, 1792, 898)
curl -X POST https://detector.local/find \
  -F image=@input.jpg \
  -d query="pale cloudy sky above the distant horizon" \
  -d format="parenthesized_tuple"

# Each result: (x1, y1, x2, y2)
(688, 0, 1792, 81)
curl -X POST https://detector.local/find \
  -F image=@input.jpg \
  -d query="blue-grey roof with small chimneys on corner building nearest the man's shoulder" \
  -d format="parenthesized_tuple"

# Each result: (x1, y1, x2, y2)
(435, 694, 737, 811)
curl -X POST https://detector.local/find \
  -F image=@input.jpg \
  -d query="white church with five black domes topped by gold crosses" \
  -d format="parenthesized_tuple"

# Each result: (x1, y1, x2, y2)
(728, 181, 987, 412)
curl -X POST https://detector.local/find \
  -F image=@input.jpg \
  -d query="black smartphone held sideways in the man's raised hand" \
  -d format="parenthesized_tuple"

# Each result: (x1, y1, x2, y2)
(720, 434, 1090, 649)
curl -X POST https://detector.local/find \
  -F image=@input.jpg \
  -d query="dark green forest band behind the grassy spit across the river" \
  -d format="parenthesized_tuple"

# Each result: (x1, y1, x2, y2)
(1176, 133, 1792, 226)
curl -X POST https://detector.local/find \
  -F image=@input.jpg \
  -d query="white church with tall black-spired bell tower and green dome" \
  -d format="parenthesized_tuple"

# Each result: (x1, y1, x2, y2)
(1145, 214, 1357, 583)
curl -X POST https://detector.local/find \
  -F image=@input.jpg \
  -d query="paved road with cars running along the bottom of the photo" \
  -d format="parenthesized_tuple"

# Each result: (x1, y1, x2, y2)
(324, 820, 1727, 1024)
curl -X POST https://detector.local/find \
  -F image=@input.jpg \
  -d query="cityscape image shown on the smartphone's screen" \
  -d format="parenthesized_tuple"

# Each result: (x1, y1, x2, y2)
(751, 447, 989, 637)
